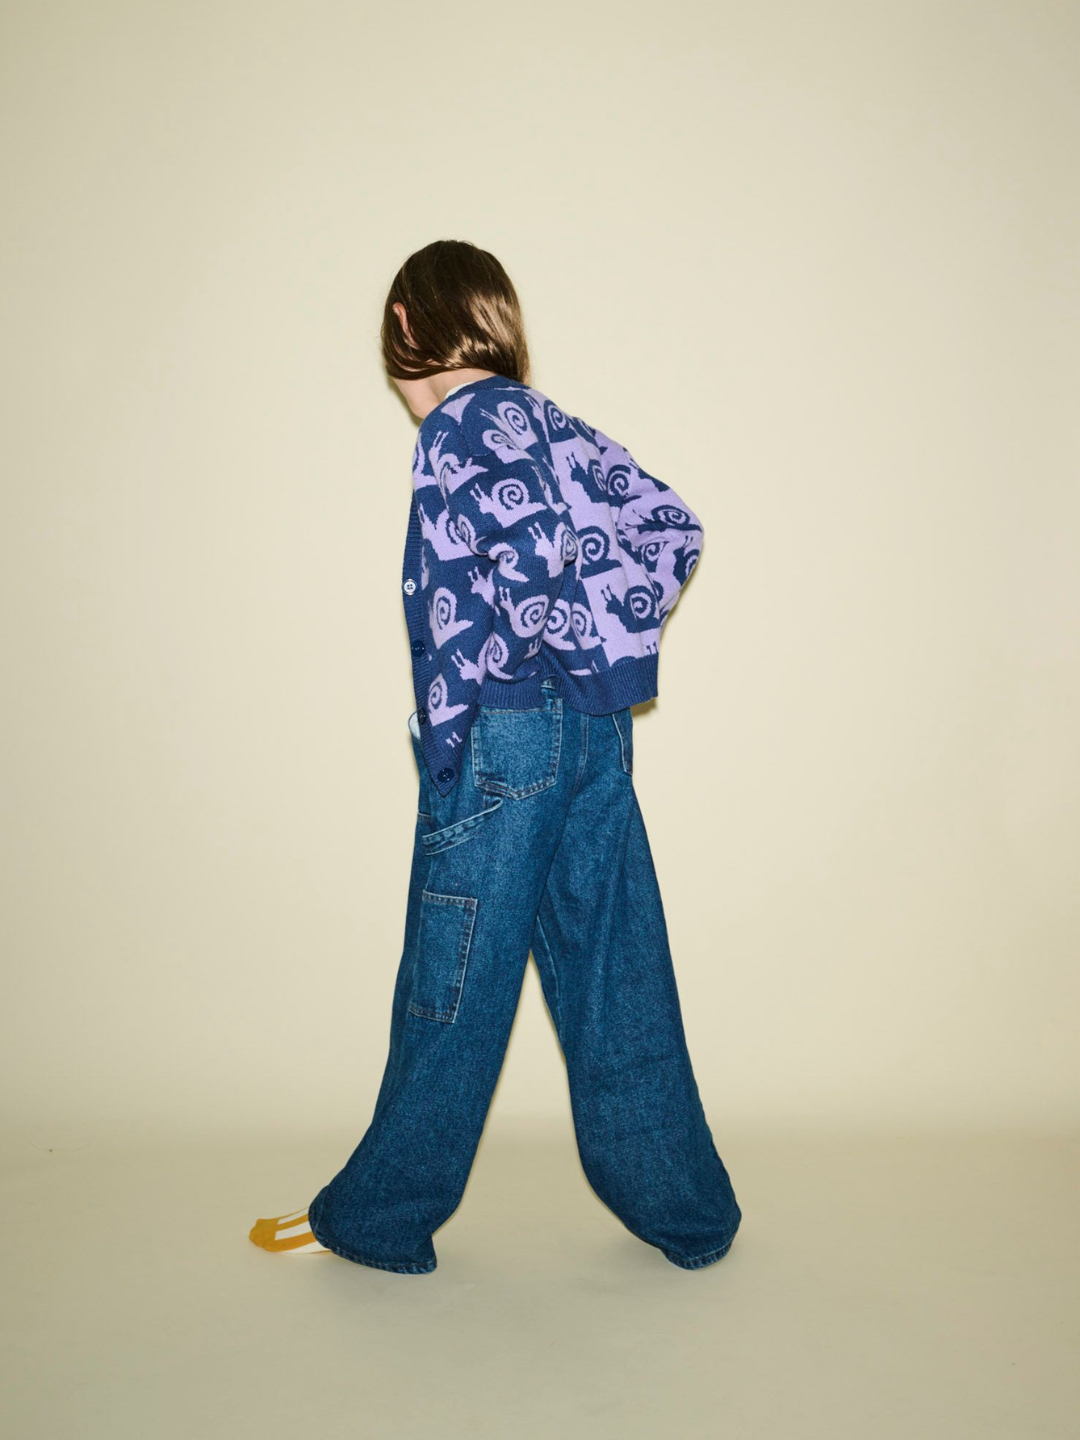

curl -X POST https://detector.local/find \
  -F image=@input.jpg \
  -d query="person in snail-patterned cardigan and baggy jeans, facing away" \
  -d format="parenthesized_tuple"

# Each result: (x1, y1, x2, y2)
(249, 240, 742, 1274)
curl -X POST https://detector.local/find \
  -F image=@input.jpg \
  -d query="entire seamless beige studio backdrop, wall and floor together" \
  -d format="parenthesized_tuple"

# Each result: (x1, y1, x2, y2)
(0, 0, 1080, 1440)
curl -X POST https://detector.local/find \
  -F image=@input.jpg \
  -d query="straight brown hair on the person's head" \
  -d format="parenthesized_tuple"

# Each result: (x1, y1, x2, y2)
(380, 240, 528, 384)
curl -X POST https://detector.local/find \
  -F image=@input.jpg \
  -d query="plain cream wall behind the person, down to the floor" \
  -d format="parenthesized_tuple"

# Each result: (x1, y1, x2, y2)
(0, 3, 1080, 1143)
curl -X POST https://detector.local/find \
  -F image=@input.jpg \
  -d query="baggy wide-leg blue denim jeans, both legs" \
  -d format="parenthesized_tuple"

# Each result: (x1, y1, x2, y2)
(308, 683, 742, 1274)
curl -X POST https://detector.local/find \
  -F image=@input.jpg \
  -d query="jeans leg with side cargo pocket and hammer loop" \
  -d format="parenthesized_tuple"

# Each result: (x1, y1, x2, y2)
(308, 698, 579, 1273)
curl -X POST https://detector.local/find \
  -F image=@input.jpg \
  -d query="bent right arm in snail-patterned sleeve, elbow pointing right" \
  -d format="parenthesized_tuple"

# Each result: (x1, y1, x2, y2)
(593, 431, 704, 629)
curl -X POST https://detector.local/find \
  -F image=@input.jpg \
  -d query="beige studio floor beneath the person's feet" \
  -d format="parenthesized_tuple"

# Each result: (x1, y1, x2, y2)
(0, 1116, 1080, 1440)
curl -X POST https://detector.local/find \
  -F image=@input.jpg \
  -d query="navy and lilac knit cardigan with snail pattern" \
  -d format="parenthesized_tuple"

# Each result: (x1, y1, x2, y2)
(402, 374, 704, 795)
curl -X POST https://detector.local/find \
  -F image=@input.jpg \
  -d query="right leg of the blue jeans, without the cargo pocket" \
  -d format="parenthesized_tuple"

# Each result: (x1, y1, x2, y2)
(533, 710, 742, 1269)
